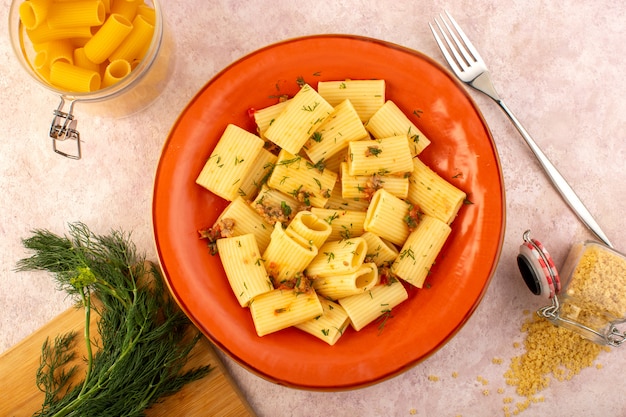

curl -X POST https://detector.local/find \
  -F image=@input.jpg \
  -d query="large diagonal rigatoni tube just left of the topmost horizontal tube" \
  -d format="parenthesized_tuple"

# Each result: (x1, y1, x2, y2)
(265, 84, 333, 154)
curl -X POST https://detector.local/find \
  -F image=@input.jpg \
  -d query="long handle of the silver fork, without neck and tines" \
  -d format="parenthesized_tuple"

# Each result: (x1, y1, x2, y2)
(495, 99, 613, 247)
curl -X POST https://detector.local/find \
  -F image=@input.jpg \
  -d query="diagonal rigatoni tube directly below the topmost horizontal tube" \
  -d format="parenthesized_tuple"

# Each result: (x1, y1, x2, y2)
(303, 100, 369, 163)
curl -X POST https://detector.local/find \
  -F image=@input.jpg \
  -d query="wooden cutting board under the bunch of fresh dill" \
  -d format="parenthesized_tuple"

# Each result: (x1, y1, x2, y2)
(0, 300, 255, 417)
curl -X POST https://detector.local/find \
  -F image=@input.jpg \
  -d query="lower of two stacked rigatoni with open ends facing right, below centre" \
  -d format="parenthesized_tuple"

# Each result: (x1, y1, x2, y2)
(313, 263, 378, 300)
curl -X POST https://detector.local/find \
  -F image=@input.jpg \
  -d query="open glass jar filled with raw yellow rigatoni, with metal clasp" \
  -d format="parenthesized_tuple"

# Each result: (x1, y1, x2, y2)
(9, 0, 172, 159)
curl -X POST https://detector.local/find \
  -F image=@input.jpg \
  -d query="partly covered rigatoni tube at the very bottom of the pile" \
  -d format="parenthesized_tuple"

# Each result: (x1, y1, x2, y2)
(295, 297, 350, 346)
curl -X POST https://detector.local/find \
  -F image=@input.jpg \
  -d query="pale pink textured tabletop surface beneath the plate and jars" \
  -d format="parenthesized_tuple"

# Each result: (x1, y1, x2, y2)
(0, 0, 626, 417)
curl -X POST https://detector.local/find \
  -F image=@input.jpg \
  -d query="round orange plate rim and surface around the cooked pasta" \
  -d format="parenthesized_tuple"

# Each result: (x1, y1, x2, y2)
(153, 35, 505, 390)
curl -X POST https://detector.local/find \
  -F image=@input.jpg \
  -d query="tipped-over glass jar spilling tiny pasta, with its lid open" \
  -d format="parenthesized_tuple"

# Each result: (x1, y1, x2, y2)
(517, 231, 626, 346)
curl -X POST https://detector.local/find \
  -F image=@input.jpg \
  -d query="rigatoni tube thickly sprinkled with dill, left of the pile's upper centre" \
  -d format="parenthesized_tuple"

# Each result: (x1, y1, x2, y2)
(267, 149, 337, 207)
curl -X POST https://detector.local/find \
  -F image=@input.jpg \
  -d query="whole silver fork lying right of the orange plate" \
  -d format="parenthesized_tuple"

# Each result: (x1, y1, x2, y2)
(428, 11, 613, 247)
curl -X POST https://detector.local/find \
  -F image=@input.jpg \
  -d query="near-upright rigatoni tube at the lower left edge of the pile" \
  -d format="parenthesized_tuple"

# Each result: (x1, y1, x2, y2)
(217, 233, 274, 307)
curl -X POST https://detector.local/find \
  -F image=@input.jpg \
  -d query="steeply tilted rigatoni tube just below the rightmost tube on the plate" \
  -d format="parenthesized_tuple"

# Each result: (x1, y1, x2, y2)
(391, 215, 451, 288)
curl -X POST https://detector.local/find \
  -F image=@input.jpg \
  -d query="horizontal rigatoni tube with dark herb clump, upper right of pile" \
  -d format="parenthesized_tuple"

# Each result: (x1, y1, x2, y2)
(348, 135, 413, 175)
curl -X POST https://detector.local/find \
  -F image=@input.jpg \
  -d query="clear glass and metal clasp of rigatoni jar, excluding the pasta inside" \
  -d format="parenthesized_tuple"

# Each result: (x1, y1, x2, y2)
(9, 0, 173, 159)
